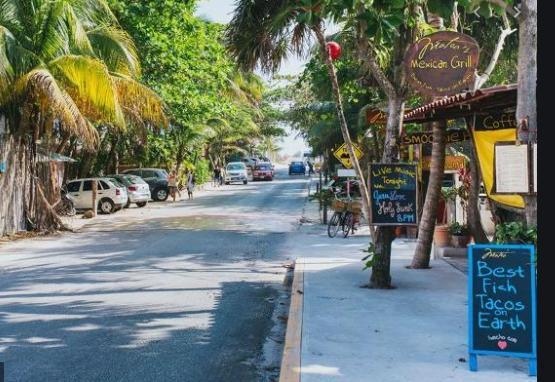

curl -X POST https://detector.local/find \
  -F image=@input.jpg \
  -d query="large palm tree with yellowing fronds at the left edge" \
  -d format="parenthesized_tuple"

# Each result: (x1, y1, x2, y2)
(0, 0, 166, 233)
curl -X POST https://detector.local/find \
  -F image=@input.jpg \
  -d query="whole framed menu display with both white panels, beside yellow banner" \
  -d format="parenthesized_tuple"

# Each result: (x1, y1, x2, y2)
(492, 141, 537, 195)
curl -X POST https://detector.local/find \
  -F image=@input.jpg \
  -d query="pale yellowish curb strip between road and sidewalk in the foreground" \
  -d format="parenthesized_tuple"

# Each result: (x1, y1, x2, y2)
(279, 262, 304, 382)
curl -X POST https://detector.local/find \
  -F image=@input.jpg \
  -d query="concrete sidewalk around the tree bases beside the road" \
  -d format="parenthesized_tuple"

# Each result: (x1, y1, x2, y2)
(280, 194, 536, 382)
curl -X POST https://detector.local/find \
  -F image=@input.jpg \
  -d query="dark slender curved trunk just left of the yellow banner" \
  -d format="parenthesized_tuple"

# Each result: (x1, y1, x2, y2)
(466, 140, 489, 244)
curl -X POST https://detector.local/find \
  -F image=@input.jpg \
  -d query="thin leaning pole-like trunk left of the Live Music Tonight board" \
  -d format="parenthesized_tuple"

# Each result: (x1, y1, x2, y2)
(314, 25, 372, 230)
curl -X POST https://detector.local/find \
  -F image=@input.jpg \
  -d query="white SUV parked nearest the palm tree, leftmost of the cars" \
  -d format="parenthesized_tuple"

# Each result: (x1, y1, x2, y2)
(66, 178, 129, 214)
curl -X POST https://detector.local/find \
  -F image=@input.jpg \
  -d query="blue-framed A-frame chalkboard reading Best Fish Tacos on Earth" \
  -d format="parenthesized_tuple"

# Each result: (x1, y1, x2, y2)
(468, 244, 536, 375)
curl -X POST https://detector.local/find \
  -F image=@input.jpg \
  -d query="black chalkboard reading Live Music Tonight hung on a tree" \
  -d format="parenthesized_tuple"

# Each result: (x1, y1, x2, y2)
(369, 163, 418, 225)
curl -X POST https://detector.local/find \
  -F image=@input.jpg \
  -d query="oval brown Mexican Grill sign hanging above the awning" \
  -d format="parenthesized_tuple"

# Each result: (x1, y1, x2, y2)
(405, 31, 479, 96)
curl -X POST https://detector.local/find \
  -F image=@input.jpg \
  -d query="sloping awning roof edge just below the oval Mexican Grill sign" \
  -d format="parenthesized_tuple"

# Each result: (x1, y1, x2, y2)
(404, 84, 517, 123)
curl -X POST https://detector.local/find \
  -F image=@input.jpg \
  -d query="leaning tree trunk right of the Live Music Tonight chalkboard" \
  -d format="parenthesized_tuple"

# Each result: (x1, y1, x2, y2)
(410, 121, 447, 269)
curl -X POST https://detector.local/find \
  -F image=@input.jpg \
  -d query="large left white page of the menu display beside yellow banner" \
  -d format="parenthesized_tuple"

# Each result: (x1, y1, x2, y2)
(495, 142, 530, 194)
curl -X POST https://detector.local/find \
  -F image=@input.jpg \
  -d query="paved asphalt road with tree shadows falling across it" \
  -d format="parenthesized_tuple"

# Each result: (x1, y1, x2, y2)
(0, 169, 307, 382)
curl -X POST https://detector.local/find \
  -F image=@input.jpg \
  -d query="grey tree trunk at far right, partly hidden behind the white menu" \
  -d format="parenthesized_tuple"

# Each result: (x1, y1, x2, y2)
(516, 0, 538, 226)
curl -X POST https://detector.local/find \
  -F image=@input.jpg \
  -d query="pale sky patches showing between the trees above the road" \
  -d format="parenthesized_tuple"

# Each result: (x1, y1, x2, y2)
(196, 0, 308, 156)
